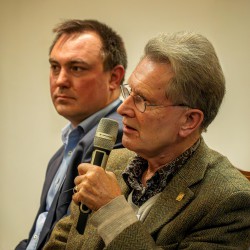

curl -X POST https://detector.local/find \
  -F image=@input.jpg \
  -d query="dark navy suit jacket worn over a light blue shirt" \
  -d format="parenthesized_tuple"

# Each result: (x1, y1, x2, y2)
(16, 102, 123, 250)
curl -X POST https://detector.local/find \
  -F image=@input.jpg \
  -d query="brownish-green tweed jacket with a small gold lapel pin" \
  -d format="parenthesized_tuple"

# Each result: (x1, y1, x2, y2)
(45, 139, 250, 250)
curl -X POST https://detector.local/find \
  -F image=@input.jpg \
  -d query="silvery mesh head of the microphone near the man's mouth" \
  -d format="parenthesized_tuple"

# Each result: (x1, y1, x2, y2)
(94, 118, 119, 151)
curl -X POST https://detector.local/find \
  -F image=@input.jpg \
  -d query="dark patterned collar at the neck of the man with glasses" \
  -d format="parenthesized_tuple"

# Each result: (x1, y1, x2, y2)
(122, 140, 200, 207)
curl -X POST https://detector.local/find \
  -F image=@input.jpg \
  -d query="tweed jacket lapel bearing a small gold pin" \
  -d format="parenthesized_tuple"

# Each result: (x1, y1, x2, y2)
(141, 140, 210, 234)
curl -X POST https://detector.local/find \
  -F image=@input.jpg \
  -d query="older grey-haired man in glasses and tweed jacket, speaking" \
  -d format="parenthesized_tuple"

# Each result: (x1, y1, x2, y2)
(45, 32, 250, 250)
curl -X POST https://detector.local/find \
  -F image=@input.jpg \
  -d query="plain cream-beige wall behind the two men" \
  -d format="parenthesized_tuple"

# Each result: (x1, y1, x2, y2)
(0, 0, 250, 250)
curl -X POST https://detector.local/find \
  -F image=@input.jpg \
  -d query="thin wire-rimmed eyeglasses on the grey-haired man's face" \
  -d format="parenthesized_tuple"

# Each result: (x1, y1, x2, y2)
(120, 84, 190, 113)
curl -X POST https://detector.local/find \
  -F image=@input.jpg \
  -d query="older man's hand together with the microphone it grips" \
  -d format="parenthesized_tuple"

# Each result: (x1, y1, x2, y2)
(73, 118, 121, 234)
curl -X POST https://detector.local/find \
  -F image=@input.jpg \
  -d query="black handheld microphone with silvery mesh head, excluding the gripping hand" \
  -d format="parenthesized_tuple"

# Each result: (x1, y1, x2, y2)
(76, 118, 119, 234)
